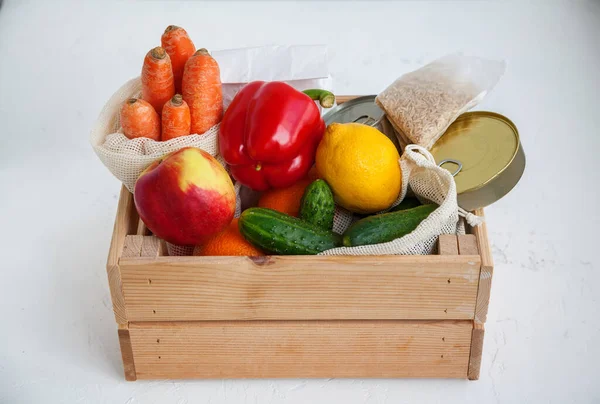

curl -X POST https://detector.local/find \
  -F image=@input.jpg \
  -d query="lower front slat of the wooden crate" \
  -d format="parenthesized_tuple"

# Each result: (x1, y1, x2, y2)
(129, 320, 472, 379)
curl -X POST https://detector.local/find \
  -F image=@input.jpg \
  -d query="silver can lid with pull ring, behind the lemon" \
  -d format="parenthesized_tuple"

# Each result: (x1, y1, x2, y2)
(323, 95, 383, 126)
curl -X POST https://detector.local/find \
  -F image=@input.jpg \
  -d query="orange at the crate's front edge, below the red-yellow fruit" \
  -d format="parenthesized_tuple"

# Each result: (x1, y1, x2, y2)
(194, 218, 265, 257)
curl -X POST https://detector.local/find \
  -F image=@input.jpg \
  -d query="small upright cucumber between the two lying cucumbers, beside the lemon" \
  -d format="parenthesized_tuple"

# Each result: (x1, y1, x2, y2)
(300, 180, 335, 230)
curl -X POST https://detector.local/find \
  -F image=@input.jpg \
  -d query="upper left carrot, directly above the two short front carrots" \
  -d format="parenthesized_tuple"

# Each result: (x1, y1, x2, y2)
(142, 46, 175, 116)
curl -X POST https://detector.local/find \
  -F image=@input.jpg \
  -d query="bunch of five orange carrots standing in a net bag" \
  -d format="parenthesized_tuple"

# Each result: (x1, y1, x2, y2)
(121, 25, 223, 141)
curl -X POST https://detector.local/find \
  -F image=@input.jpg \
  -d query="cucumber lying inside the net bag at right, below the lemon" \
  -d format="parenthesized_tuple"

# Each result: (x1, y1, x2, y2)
(343, 204, 438, 247)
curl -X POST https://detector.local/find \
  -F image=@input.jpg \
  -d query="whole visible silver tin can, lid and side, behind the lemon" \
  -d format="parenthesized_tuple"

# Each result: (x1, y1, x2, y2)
(323, 95, 400, 150)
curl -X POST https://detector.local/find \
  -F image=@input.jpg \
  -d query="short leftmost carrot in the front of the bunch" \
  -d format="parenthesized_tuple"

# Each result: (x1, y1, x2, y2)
(121, 98, 160, 140)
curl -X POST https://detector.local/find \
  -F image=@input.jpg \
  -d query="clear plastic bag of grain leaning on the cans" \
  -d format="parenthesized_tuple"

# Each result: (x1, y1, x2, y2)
(375, 53, 505, 149)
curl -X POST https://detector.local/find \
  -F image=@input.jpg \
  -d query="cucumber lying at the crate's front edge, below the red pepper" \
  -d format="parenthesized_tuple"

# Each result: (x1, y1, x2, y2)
(239, 208, 342, 255)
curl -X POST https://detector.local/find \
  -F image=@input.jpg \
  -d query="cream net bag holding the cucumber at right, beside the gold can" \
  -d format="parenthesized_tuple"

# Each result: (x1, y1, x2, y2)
(320, 145, 482, 255)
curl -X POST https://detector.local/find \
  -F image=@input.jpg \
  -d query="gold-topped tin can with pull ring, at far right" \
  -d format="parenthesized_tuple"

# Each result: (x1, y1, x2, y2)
(431, 111, 525, 211)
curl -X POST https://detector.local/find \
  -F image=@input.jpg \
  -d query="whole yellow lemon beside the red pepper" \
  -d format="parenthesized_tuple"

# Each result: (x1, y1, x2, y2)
(316, 123, 402, 213)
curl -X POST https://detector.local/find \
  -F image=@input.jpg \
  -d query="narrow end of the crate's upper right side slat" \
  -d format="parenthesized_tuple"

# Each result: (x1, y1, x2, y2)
(472, 209, 494, 323)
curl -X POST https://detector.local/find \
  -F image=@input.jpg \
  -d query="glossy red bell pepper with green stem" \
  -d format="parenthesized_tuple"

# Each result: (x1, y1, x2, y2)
(219, 81, 335, 191)
